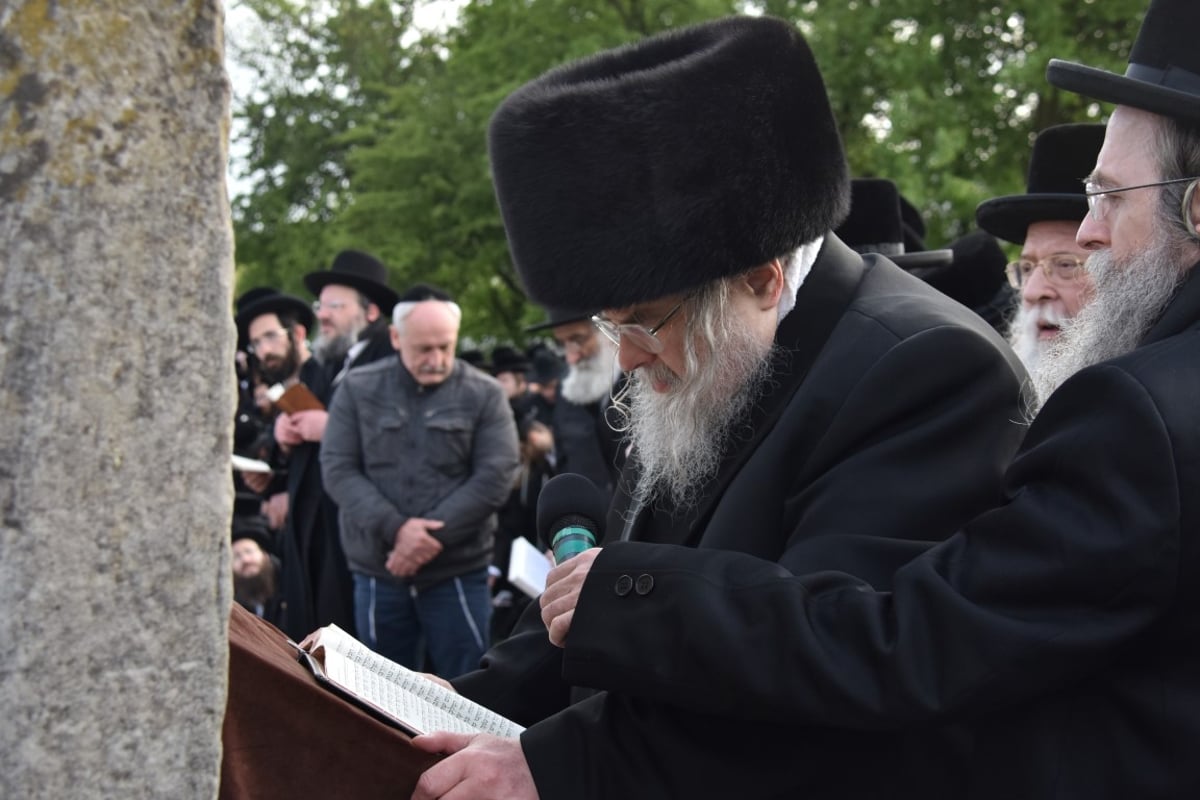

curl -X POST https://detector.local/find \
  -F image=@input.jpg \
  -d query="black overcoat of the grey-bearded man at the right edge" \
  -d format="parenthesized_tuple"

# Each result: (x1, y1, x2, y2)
(564, 265, 1200, 800)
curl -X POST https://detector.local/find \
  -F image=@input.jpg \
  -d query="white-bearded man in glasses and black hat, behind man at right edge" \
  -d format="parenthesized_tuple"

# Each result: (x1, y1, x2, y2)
(976, 124, 1104, 373)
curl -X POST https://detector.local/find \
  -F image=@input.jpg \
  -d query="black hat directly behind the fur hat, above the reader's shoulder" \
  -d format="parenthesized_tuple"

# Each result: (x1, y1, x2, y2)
(834, 178, 954, 270)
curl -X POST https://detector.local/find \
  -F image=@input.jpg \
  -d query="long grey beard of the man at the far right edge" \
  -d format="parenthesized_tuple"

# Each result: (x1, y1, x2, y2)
(1032, 235, 1187, 411)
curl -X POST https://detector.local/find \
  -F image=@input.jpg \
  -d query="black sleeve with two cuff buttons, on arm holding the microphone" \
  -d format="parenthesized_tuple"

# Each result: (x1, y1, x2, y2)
(564, 367, 1181, 729)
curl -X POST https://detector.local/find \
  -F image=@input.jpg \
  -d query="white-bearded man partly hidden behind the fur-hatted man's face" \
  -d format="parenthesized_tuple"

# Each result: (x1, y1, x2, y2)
(527, 308, 624, 500)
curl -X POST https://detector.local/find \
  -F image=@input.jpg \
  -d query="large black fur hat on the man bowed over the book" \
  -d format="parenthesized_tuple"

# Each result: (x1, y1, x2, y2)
(488, 17, 850, 308)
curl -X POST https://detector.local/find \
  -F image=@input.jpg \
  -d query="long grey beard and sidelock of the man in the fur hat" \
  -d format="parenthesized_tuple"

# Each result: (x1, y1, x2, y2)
(624, 287, 774, 510)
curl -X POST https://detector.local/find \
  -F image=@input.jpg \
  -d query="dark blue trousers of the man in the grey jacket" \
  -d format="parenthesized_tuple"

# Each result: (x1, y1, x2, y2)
(354, 567, 492, 678)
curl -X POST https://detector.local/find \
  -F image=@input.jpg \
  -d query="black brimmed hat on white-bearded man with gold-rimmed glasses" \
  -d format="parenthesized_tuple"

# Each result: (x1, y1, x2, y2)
(976, 124, 1104, 245)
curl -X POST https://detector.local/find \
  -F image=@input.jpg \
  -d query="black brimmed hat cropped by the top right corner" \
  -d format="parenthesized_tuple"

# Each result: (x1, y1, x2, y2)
(1046, 0, 1200, 125)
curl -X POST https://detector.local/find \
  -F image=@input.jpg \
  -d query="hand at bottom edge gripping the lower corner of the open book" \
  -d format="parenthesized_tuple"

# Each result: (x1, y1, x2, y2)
(413, 733, 538, 800)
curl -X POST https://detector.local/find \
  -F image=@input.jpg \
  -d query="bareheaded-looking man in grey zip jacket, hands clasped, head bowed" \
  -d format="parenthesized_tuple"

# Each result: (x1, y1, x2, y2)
(320, 285, 518, 676)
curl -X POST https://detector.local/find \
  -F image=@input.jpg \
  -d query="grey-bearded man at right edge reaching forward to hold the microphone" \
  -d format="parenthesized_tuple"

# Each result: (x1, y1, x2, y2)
(465, 0, 1200, 800)
